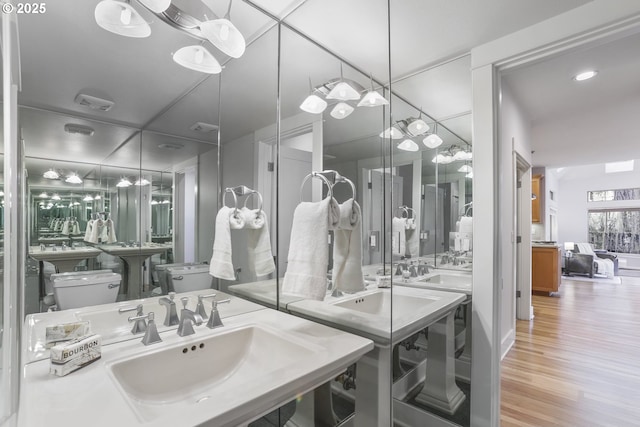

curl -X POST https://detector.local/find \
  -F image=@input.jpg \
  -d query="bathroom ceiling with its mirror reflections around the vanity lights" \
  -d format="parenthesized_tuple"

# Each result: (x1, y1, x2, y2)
(8, 0, 600, 187)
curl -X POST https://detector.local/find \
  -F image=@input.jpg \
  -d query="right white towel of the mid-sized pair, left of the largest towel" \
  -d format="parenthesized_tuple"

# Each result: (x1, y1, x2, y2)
(240, 207, 276, 276)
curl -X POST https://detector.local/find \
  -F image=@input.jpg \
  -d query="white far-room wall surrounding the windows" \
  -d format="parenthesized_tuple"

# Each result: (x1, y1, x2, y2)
(558, 160, 640, 247)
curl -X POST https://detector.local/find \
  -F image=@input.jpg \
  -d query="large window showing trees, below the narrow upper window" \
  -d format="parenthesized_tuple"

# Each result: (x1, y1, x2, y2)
(588, 209, 640, 254)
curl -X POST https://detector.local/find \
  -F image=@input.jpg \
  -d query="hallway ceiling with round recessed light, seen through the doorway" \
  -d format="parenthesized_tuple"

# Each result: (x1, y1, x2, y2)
(504, 29, 640, 167)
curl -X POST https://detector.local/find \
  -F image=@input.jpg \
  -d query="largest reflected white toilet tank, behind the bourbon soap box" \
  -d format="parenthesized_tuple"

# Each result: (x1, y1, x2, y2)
(52, 270, 122, 310)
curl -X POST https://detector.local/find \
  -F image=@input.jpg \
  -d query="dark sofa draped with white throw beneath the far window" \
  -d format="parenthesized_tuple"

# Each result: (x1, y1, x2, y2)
(565, 243, 618, 277)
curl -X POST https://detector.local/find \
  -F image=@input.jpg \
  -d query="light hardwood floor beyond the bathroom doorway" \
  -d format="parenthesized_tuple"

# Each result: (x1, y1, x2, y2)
(501, 277, 640, 427)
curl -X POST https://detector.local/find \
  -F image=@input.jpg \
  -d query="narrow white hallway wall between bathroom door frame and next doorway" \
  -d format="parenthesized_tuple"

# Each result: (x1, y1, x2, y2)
(498, 80, 531, 357)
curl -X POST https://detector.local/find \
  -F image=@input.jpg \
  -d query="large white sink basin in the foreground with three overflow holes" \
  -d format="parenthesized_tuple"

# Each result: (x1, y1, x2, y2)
(109, 325, 321, 421)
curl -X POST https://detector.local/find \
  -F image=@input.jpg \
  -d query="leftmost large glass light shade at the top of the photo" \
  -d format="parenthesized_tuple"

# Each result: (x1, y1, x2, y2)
(94, 0, 151, 38)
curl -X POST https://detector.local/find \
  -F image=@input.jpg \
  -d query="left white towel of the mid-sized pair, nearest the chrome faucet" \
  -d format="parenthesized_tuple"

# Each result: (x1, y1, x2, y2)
(209, 206, 244, 280)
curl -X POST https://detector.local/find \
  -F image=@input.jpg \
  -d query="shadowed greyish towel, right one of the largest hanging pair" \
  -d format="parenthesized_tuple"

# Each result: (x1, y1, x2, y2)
(332, 199, 365, 293)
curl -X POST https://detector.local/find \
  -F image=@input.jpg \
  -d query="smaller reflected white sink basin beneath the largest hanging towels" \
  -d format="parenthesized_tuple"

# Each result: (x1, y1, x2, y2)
(333, 291, 435, 319)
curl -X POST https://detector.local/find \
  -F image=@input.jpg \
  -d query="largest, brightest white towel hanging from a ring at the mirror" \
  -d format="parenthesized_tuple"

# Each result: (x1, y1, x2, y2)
(282, 197, 340, 301)
